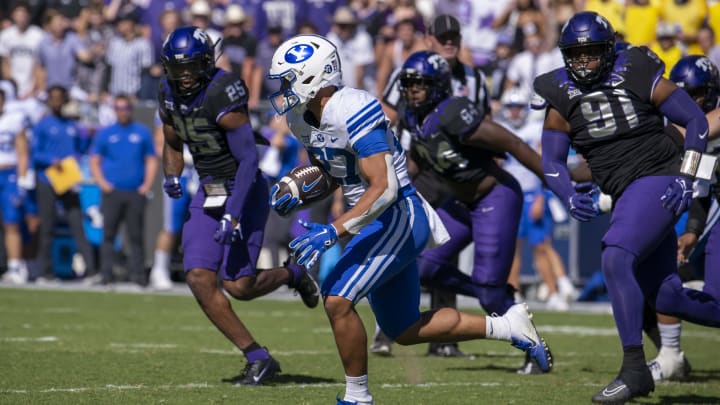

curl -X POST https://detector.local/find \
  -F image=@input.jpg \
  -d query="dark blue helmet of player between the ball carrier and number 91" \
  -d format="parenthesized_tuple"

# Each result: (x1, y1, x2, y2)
(399, 51, 452, 114)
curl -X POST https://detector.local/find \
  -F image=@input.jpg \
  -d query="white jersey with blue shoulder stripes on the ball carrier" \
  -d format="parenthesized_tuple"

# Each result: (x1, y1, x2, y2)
(286, 87, 410, 205)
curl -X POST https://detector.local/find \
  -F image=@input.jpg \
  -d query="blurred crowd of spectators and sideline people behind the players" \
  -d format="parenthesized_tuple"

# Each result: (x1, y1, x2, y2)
(0, 0, 720, 302)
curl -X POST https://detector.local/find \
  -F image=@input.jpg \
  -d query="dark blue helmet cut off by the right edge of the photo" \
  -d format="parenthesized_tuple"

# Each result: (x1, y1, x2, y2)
(670, 55, 720, 112)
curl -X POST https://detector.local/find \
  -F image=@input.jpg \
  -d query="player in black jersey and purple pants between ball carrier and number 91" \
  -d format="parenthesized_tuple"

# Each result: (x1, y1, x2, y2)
(398, 51, 550, 372)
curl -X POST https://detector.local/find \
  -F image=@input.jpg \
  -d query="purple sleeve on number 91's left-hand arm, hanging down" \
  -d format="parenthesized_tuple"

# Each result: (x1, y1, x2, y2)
(542, 129, 575, 204)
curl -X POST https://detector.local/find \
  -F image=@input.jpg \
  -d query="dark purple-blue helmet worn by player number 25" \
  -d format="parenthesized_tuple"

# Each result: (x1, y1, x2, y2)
(160, 27, 216, 98)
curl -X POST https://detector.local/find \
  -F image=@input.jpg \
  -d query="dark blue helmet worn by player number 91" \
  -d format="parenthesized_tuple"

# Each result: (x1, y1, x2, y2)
(558, 11, 615, 86)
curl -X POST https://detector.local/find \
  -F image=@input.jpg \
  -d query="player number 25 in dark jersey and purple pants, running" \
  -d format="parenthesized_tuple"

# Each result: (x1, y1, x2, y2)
(158, 27, 319, 385)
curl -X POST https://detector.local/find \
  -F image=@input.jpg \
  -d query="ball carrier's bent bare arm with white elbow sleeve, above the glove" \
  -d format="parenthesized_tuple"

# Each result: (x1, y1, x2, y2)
(333, 152, 398, 236)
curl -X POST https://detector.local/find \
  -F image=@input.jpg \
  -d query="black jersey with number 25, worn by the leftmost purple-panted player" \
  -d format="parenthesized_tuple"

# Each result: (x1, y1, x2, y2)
(158, 69, 248, 180)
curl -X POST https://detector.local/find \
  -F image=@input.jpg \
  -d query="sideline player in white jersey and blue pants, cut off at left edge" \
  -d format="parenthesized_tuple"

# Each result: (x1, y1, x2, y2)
(0, 90, 29, 284)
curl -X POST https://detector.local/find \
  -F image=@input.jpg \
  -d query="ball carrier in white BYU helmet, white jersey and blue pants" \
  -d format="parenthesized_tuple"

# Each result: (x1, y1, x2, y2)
(268, 35, 550, 404)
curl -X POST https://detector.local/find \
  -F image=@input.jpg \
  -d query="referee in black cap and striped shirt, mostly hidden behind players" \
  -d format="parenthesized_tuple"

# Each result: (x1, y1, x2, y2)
(370, 14, 491, 357)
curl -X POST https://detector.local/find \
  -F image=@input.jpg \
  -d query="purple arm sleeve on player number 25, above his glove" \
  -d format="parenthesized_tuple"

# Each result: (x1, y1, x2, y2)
(225, 123, 258, 221)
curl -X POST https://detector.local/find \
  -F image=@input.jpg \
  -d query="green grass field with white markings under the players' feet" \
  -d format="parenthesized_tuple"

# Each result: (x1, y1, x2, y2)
(0, 288, 720, 405)
